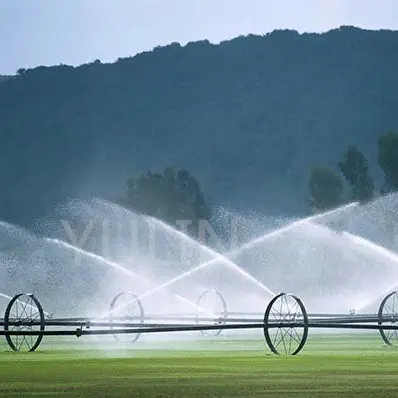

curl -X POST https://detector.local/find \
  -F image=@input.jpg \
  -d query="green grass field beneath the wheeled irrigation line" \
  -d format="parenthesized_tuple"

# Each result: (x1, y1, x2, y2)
(0, 332, 398, 398)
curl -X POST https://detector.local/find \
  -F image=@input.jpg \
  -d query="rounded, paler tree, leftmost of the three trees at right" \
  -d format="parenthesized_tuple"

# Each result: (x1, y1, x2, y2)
(308, 166, 343, 211)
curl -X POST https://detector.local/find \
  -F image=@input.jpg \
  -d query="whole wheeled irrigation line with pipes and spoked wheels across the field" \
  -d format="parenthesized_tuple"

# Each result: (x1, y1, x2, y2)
(0, 291, 398, 355)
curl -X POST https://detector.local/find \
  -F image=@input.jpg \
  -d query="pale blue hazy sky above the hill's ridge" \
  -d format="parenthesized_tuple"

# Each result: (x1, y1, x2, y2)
(0, 0, 398, 74)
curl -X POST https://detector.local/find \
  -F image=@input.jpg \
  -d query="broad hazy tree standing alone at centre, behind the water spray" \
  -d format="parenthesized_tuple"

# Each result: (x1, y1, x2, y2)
(124, 167, 211, 233)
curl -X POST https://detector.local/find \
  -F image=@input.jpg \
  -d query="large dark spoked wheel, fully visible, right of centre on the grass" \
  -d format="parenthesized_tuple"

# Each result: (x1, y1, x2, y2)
(264, 293, 308, 355)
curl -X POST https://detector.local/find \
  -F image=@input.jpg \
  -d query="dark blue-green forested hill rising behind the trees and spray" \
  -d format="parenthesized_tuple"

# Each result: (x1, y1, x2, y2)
(0, 27, 398, 224)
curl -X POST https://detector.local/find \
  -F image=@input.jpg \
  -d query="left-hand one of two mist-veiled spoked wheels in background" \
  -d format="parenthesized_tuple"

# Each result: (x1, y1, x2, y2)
(110, 292, 145, 343)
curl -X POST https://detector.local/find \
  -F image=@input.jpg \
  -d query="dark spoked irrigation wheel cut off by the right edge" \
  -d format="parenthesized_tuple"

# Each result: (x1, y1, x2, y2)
(378, 292, 398, 346)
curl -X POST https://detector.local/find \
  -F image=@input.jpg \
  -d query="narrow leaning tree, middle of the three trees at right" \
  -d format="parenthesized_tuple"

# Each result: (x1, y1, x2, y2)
(338, 146, 374, 203)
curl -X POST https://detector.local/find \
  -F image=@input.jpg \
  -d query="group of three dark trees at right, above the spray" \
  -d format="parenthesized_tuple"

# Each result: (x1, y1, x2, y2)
(308, 132, 398, 212)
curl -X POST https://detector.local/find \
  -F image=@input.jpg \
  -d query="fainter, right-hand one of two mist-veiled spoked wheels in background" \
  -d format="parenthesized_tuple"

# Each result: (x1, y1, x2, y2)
(196, 290, 228, 337)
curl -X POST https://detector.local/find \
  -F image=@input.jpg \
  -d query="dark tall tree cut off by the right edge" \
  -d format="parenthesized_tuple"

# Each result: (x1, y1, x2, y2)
(378, 132, 398, 193)
